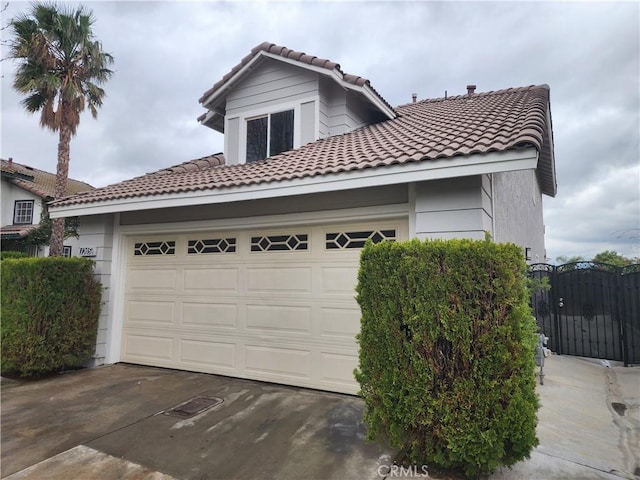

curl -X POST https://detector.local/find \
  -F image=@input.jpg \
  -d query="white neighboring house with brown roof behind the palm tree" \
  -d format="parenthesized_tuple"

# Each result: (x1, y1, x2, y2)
(0, 158, 93, 257)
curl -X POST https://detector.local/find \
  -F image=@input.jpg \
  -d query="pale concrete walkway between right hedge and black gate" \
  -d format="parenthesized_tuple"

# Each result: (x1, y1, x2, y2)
(490, 355, 640, 480)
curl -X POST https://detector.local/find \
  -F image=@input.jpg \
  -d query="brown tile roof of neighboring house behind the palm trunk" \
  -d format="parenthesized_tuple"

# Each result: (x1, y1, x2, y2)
(0, 159, 93, 199)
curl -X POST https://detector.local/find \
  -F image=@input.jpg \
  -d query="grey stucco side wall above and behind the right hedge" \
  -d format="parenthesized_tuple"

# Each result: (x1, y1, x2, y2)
(493, 170, 546, 263)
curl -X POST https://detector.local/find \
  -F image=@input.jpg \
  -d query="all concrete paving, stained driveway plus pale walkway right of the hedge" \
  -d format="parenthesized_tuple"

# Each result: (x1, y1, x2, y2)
(1, 356, 640, 480)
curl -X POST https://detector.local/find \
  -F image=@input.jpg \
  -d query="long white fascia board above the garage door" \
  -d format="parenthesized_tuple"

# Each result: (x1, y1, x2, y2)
(49, 147, 538, 218)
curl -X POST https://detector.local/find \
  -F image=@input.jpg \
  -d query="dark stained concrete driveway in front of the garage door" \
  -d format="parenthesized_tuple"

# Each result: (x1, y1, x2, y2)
(2, 364, 392, 480)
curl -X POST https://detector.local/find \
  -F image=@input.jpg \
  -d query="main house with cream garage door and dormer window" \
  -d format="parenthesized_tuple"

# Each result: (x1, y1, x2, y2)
(51, 43, 556, 393)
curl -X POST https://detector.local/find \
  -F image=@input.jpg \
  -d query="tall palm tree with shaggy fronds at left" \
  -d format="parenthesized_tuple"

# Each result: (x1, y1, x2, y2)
(9, 3, 113, 256)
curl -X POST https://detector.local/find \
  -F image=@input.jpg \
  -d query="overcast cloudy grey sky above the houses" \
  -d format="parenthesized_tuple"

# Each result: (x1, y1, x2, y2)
(1, 1, 640, 260)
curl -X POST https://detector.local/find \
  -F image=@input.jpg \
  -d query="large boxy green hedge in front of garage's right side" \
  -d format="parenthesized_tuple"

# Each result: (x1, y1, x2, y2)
(355, 240, 539, 476)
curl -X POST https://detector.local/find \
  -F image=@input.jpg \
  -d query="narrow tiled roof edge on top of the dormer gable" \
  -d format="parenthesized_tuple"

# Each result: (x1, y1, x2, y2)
(198, 42, 393, 115)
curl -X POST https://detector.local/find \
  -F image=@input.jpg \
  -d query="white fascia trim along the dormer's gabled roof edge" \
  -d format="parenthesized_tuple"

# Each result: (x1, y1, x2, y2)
(202, 50, 396, 119)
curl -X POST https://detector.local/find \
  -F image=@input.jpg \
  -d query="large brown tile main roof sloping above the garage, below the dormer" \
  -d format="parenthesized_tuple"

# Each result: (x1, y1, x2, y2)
(55, 85, 555, 206)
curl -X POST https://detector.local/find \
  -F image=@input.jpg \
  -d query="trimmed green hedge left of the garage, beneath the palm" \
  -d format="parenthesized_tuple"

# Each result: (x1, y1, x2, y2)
(1, 257, 102, 376)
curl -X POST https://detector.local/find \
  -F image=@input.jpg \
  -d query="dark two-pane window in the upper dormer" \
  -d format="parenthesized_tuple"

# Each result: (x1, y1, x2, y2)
(247, 110, 293, 162)
